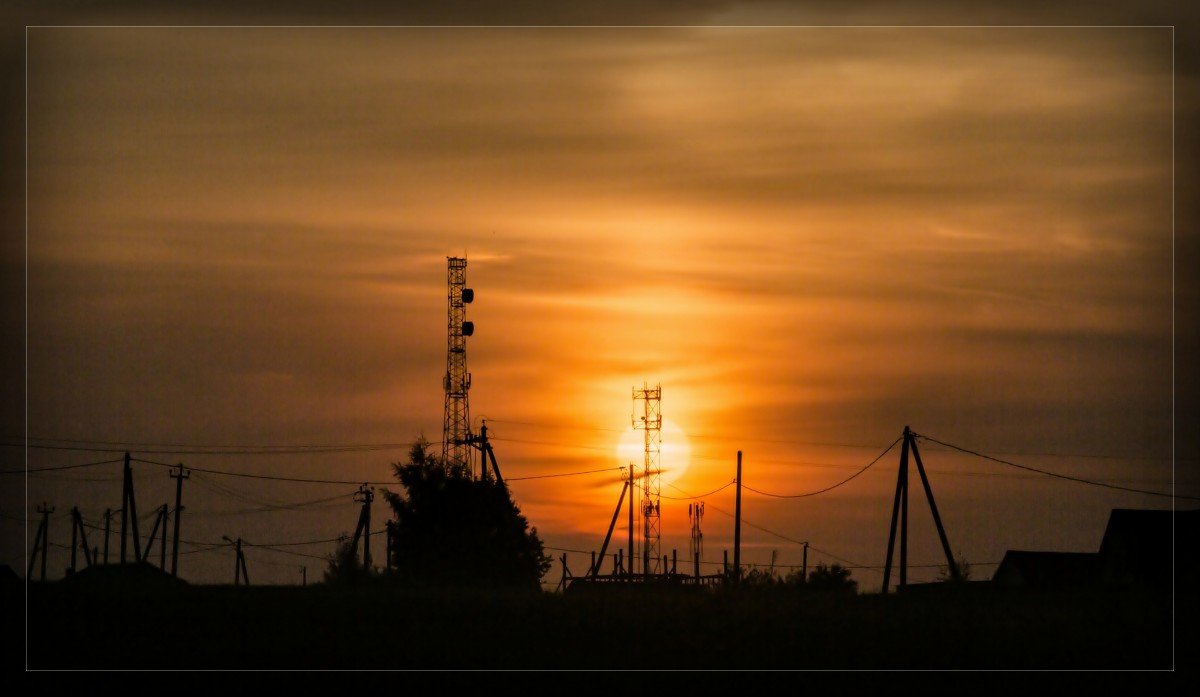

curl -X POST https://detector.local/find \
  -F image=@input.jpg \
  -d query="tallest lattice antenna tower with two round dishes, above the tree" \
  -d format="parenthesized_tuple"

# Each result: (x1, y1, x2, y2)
(442, 257, 475, 474)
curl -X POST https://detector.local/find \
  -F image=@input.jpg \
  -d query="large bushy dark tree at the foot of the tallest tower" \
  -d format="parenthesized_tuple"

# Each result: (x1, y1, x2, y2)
(384, 437, 551, 589)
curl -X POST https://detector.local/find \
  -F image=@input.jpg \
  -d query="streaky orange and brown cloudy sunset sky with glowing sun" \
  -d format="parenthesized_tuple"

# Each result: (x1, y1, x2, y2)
(2, 11, 1200, 590)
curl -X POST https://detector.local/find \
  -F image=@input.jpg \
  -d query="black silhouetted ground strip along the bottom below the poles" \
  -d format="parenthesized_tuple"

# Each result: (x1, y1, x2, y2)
(23, 583, 1198, 669)
